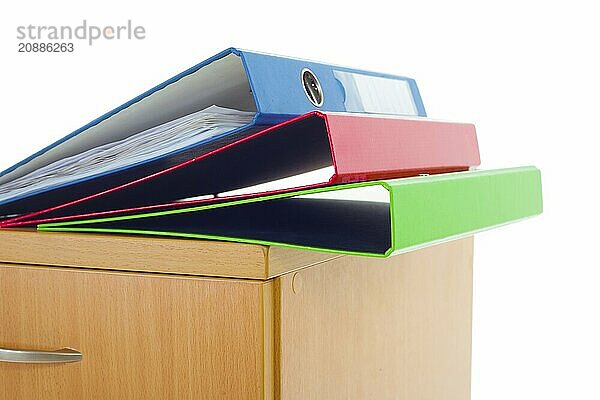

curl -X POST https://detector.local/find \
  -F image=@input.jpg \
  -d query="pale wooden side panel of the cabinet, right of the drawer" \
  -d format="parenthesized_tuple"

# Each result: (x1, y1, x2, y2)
(275, 238, 473, 400)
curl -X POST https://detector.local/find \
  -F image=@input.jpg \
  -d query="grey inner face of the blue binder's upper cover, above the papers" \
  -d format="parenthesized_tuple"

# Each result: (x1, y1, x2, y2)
(0, 53, 256, 185)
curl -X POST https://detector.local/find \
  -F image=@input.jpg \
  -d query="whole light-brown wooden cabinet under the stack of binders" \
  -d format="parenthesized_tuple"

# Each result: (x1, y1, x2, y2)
(0, 231, 472, 400)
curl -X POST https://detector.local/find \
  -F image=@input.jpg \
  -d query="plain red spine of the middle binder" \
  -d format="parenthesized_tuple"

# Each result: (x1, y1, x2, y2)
(325, 114, 481, 182)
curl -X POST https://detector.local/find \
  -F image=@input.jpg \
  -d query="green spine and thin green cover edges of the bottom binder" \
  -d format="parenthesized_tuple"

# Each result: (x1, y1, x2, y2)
(38, 167, 543, 257)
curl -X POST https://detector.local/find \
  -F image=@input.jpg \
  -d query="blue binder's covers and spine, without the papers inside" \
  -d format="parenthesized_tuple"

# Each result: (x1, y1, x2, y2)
(0, 48, 426, 219)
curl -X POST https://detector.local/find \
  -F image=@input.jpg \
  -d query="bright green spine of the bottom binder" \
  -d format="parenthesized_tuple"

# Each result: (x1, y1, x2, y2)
(385, 167, 543, 254)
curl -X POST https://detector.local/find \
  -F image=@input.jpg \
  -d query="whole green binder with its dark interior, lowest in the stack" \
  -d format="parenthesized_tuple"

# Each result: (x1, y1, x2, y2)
(38, 167, 542, 257)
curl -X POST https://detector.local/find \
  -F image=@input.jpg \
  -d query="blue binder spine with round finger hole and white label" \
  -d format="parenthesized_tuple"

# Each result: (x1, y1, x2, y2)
(236, 50, 426, 117)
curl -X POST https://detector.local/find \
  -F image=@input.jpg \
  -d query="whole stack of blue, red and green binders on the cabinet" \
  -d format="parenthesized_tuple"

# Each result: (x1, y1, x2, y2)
(0, 49, 542, 257)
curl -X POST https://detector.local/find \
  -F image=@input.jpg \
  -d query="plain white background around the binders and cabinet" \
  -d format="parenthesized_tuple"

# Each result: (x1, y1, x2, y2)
(0, 0, 600, 400)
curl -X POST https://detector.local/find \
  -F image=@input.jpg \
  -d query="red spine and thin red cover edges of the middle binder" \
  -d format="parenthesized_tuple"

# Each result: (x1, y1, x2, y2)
(0, 111, 480, 228)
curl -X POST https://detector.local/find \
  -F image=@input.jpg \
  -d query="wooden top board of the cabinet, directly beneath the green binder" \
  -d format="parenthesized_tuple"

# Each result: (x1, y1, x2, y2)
(0, 229, 340, 280)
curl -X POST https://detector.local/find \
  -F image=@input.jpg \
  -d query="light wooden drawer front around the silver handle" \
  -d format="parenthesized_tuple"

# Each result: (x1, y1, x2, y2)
(0, 264, 264, 400)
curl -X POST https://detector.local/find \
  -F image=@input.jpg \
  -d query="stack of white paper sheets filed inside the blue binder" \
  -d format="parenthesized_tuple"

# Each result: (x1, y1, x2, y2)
(0, 105, 255, 201)
